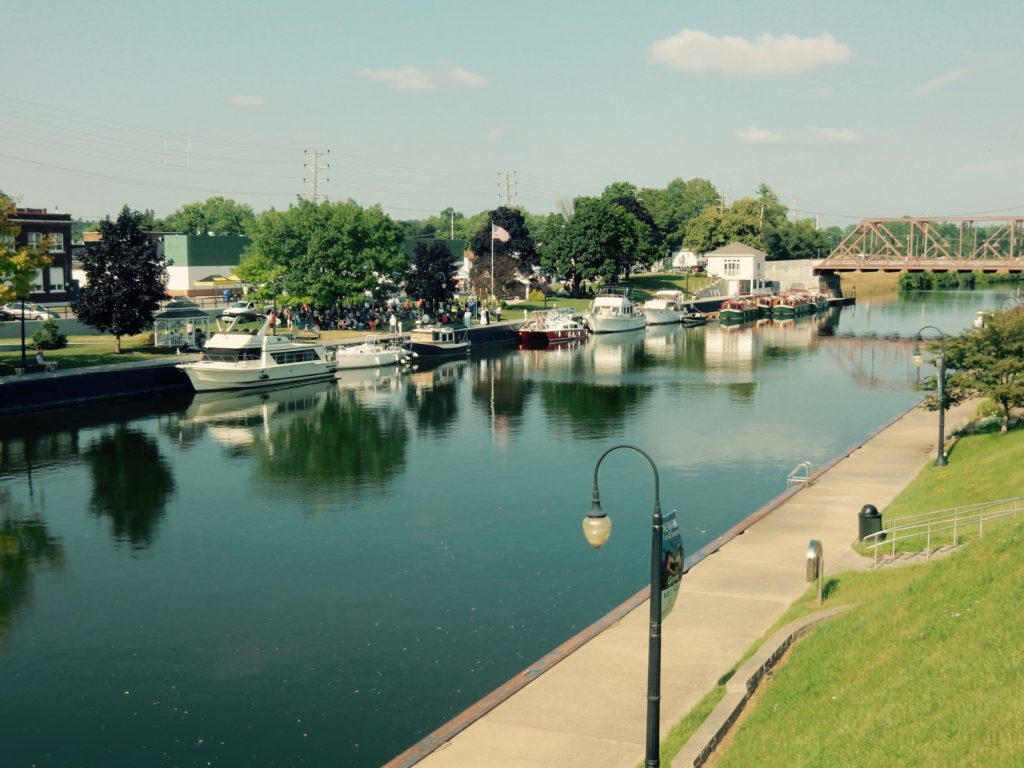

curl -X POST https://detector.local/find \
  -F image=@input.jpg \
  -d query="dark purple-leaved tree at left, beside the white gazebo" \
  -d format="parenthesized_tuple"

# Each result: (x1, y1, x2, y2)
(71, 206, 167, 353)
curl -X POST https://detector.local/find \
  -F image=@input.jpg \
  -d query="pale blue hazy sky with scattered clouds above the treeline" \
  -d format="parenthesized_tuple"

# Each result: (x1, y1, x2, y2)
(0, 0, 1024, 226)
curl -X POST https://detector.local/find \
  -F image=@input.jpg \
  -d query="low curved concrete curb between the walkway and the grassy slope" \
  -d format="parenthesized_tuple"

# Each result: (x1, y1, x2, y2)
(672, 605, 855, 768)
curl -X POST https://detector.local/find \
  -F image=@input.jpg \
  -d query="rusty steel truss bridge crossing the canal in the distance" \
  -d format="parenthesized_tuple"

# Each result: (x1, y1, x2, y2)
(814, 216, 1024, 275)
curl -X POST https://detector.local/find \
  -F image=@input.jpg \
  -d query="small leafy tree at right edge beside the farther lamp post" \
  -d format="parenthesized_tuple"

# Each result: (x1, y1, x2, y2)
(930, 306, 1024, 432)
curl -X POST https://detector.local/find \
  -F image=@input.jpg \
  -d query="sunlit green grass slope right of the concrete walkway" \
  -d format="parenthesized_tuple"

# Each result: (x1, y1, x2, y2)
(663, 430, 1024, 768)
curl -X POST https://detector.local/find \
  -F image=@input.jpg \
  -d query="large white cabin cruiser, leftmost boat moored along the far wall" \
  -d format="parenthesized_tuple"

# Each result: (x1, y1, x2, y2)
(176, 314, 337, 392)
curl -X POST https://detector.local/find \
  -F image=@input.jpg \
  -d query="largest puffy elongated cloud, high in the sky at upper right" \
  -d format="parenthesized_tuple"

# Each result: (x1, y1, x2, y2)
(649, 30, 850, 75)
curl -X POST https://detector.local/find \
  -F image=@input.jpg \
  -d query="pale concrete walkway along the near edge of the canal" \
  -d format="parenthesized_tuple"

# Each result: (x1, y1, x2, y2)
(388, 403, 975, 768)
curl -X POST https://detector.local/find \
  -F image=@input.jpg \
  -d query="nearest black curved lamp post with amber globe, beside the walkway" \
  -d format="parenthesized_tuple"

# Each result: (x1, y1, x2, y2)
(583, 444, 662, 768)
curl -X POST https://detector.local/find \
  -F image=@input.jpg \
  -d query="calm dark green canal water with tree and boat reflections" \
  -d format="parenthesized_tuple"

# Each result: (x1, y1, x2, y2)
(0, 291, 1010, 767)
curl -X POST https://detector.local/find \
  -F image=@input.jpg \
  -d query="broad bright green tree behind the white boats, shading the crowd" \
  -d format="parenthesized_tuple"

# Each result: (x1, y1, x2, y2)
(238, 200, 408, 306)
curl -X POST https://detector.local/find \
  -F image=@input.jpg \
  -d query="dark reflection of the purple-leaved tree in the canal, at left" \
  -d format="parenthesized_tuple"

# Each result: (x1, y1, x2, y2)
(83, 424, 174, 549)
